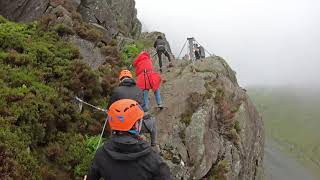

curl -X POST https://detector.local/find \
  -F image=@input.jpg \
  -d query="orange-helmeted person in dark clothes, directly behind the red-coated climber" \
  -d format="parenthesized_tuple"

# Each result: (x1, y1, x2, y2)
(108, 70, 157, 149)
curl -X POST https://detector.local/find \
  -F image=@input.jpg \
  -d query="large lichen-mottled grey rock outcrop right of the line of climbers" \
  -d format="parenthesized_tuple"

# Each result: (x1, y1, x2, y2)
(153, 57, 264, 180)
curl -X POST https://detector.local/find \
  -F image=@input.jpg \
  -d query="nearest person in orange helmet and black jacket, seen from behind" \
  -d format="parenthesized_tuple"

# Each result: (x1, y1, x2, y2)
(87, 99, 171, 180)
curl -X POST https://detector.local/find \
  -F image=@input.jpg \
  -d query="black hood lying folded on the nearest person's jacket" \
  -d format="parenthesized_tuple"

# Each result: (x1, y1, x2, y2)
(103, 135, 152, 161)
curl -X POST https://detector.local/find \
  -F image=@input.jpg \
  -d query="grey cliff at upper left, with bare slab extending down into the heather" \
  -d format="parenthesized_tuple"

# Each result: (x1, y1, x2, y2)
(0, 0, 142, 68)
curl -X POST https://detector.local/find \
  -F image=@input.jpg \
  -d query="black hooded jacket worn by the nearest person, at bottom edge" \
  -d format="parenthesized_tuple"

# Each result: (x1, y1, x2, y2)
(87, 135, 171, 180)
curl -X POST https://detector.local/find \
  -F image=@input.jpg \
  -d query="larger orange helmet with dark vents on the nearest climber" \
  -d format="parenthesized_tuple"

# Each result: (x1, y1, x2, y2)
(108, 99, 144, 131)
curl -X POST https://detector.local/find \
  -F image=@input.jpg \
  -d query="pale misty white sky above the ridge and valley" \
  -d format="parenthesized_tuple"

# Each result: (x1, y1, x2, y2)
(136, 0, 320, 87)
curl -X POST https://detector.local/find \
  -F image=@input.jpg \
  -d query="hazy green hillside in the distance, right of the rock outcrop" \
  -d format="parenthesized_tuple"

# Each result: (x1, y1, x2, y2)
(248, 88, 320, 177)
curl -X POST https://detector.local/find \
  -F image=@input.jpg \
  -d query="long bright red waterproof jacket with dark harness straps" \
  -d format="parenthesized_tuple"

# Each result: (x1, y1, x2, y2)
(133, 51, 161, 91)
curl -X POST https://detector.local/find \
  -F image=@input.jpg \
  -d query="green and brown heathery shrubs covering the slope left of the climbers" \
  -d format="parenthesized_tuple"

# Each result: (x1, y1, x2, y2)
(0, 16, 117, 179)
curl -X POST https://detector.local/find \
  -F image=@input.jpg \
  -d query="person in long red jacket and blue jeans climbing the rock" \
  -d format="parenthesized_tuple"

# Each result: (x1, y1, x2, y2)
(133, 51, 163, 111)
